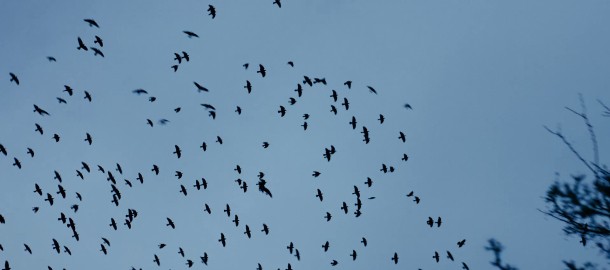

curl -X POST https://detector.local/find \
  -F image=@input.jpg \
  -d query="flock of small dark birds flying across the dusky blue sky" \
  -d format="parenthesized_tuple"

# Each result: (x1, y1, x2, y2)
(0, 0, 469, 270)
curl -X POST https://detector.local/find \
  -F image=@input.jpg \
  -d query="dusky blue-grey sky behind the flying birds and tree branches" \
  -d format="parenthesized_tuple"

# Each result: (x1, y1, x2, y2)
(0, 0, 610, 269)
